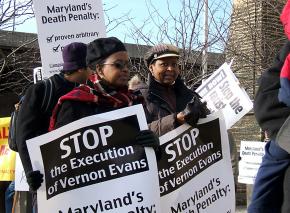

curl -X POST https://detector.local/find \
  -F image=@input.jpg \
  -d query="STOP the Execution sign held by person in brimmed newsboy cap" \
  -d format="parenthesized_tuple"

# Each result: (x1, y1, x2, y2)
(158, 113, 235, 213)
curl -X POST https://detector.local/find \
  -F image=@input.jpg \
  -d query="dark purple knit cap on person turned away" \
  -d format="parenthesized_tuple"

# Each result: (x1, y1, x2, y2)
(62, 42, 87, 72)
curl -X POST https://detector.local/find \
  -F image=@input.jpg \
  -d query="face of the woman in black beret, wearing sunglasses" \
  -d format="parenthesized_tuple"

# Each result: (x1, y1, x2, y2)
(98, 51, 129, 88)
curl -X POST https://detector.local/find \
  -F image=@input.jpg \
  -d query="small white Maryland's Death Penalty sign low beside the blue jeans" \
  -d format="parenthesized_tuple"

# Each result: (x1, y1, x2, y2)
(238, 141, 266, 184)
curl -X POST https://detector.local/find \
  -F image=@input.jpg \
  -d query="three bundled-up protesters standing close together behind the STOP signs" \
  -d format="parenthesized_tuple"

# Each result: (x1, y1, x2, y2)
(1, 37, 209, 213)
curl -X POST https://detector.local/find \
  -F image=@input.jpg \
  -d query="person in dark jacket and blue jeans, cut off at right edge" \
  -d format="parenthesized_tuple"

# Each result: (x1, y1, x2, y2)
(248, 41, 290, 213)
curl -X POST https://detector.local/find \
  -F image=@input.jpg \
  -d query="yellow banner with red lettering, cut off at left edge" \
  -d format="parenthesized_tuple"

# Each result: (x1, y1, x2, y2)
(0, 117, 16, 181)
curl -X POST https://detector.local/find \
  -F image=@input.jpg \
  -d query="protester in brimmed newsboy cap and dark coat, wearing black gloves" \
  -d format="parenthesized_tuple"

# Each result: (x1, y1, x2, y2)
(141, 44, 209, 136)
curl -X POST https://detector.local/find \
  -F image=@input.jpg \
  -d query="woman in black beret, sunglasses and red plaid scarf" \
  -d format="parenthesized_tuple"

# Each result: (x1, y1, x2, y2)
(21, 37, 159, 189)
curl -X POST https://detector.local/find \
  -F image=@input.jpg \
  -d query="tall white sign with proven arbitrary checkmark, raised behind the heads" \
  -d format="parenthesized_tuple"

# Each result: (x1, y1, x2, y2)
(33, 0, 106, 78)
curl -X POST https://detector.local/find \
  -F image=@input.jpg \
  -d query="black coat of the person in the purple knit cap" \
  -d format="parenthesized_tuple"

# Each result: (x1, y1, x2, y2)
(16, 74, 77, 173)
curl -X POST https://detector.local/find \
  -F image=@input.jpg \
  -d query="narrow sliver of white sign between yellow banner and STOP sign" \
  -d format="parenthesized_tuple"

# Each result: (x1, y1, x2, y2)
(15, 153, 29, 191)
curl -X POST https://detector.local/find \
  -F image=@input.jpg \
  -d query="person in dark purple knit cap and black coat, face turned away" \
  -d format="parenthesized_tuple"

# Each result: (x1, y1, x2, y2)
(16, 42, 91, 195)
